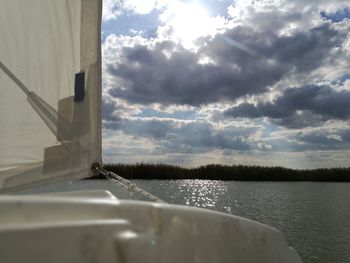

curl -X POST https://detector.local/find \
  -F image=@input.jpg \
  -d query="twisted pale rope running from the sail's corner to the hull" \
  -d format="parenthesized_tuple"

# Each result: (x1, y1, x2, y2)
(94, 167, 164, 203)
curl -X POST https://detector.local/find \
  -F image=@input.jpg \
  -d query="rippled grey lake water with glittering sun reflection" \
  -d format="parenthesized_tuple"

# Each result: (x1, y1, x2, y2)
(18, 180, 350, 263)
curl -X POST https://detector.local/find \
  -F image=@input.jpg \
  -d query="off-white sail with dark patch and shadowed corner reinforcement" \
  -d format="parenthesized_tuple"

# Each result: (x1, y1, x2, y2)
(0, 0, 102, 194)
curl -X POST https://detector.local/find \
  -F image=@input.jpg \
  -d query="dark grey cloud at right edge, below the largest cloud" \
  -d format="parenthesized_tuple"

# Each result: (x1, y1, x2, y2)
(224, 85, 350, 128)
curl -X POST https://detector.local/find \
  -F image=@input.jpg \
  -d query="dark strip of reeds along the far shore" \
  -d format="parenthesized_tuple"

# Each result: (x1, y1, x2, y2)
(100, 163, 350, 182)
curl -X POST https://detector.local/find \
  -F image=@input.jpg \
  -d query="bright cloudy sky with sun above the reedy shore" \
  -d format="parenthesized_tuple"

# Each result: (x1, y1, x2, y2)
(102, 0, 350, 169)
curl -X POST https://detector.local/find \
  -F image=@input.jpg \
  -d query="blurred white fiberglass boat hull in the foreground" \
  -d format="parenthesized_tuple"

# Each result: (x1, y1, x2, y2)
(0, 191, 301, 263)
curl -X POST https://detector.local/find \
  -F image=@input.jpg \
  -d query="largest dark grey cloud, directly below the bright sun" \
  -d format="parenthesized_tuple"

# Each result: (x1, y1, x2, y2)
(107, 20, 344, 106)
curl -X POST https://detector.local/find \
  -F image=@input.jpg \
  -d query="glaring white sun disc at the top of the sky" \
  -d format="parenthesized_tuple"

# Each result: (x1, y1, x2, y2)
(169, 3, 212, 47)
